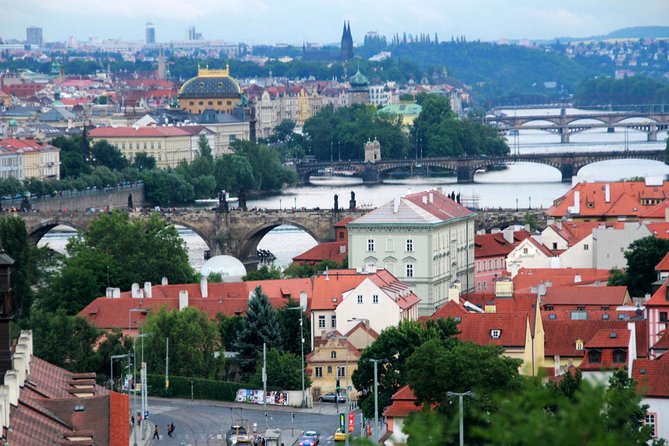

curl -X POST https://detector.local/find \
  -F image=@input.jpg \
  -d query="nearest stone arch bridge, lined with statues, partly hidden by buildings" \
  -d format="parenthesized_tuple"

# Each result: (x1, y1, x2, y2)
(18, 209, 545, 269)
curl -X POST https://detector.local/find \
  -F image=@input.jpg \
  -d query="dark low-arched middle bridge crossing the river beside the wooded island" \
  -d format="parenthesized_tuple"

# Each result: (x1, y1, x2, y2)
(296, 150, 666, 184)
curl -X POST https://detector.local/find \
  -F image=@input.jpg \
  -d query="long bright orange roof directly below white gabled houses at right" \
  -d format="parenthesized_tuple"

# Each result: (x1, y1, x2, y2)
(513, 268, 610, 293)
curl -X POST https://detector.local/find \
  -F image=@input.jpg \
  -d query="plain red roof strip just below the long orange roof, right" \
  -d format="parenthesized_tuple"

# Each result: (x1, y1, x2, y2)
(541, 286, 631, 307)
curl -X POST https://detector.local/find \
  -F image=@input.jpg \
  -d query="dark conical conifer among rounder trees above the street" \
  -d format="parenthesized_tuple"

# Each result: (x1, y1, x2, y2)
(236, 287, 282, 379)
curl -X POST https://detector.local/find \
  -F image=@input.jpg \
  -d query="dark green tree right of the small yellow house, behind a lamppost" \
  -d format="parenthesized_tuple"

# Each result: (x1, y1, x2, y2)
(351, 319, 458, 418)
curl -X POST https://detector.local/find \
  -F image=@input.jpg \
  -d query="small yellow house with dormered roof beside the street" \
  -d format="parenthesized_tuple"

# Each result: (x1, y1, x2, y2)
(306, 336, 360, 400)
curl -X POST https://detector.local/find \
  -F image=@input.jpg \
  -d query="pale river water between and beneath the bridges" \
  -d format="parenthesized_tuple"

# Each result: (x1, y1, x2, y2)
(40, 109, 669, 270)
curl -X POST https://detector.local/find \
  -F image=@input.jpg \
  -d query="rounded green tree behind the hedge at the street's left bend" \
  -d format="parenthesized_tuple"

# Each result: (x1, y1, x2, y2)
(142, 307, 224, 379)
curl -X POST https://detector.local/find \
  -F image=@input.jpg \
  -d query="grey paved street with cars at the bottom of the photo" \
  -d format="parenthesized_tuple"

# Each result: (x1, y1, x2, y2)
(140, 398, 360, 446)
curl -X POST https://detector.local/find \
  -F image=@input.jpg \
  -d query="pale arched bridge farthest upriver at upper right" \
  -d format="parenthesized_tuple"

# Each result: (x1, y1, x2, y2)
(487, 109, 669, 143)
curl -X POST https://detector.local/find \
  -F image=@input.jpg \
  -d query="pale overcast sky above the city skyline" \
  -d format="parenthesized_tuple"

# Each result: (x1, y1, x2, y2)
(0, 0, 669, 44)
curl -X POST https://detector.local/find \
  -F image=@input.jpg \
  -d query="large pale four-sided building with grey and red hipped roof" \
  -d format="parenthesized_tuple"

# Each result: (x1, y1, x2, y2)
(347, 190, 476, 316)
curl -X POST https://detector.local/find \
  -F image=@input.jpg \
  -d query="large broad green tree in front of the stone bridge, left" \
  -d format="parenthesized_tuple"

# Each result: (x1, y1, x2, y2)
(41, 211, 195, 314)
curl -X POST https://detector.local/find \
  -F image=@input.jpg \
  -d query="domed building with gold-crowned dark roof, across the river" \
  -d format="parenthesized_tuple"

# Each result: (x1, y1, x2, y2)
(178, 66, 242, 114)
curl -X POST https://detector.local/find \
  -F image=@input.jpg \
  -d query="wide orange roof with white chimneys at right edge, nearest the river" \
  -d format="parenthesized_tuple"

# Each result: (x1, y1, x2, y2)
(546, 181, 669, 219)
